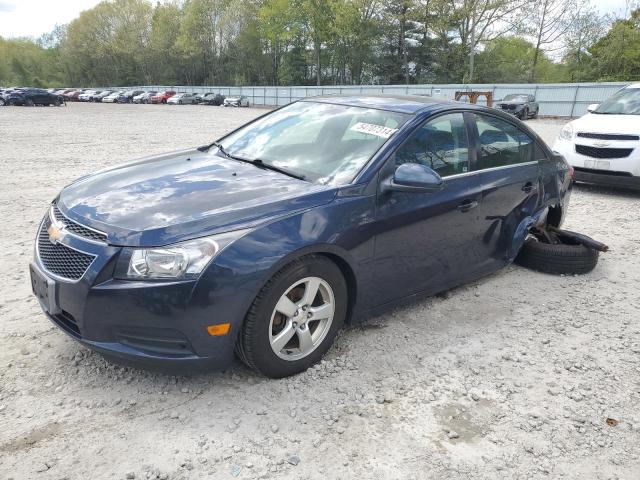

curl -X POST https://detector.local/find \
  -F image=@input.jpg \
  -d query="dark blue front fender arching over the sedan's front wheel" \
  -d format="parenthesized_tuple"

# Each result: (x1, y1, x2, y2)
(193, 197, 375, 334)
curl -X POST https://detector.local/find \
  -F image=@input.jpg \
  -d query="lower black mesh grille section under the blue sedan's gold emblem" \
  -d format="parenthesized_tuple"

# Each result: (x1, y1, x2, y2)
(37, 221, 96, 280)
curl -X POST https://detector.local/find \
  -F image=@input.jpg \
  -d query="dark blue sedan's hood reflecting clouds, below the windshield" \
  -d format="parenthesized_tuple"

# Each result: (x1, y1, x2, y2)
(58, 149, 336, 246)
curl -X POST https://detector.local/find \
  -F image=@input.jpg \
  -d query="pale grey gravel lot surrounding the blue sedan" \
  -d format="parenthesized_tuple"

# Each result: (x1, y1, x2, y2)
(0, 104, 640, 480)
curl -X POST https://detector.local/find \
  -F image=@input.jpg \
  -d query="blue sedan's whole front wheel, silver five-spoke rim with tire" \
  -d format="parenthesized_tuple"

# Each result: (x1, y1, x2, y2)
(236, 255, 347, 378)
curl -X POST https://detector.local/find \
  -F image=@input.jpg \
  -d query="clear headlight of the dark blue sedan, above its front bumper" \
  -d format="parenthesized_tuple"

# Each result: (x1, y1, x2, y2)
(115, 229, 249, 280)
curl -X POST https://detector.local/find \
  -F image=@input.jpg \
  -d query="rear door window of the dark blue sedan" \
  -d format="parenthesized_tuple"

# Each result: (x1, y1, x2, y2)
(475, 115, 535, 170)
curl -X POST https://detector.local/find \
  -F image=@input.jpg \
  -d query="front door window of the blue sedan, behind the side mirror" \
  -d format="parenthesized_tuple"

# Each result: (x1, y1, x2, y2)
(395, 113, 469, 177)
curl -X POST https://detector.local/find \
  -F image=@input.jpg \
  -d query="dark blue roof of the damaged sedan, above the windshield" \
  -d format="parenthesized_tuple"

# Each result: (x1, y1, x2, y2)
(302, 94, 458, 114)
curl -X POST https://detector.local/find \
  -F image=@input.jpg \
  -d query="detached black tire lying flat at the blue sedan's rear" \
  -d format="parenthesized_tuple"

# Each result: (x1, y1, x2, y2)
(515, 238, 599, 275)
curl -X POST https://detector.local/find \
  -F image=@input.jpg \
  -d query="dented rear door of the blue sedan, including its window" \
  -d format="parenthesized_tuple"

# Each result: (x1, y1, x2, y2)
(471, 114, 540, 271)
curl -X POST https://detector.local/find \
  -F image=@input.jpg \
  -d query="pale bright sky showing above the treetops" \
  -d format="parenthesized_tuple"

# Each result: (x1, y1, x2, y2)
(0, 0, 627, 38)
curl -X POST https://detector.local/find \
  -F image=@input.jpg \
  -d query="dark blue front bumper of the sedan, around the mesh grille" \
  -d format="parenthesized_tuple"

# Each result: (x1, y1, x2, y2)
(30, 212, 247, 373)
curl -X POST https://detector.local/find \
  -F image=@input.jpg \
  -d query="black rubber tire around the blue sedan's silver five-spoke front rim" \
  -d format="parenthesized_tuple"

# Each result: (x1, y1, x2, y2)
(236, 255, 348, 378)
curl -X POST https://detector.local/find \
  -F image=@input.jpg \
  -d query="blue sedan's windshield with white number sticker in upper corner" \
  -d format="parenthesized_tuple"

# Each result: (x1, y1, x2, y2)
(220, 101, 409, 185)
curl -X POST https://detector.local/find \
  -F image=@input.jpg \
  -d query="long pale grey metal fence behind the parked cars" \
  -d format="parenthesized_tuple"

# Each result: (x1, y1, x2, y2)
(103, 83, 628, 117)
